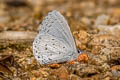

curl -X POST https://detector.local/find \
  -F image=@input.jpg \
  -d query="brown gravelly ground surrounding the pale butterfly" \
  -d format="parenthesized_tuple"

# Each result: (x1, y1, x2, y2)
(0, 0, 120, 80)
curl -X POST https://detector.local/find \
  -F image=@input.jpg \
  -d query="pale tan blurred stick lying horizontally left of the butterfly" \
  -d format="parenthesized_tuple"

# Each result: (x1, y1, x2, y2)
(0, 31, 37, 48)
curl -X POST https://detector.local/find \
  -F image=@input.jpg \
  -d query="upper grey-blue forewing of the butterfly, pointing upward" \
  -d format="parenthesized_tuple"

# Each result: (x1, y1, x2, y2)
(40, 10, 77, 52)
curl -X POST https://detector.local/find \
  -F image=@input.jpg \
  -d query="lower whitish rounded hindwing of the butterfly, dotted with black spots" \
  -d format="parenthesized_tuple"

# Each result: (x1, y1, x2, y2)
(33, 34, 74, 64)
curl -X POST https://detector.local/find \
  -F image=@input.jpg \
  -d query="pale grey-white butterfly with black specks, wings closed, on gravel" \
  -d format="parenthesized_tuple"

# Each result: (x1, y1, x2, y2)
(33, 10, 79, 64)
